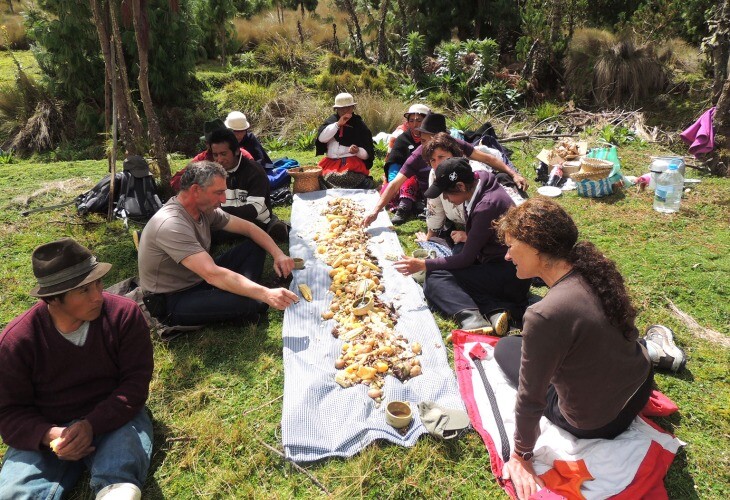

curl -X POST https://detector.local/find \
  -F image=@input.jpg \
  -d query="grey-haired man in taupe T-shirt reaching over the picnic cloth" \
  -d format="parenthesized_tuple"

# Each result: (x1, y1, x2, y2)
(139, 158, 297, 326)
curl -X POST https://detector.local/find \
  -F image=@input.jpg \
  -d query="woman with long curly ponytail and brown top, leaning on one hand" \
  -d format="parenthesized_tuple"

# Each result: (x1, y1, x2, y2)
(494, 198, 653, 499)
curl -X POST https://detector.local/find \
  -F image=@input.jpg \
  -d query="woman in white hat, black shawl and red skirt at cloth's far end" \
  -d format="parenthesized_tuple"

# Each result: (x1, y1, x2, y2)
(315, 92, 375, 189)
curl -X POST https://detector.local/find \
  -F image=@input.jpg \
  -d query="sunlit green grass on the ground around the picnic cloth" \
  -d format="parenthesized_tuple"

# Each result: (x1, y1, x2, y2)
(0, 142, 730, 499)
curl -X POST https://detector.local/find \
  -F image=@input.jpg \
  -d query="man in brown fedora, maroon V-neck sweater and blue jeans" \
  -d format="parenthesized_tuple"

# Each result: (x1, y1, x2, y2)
(0, 238, 153, 499)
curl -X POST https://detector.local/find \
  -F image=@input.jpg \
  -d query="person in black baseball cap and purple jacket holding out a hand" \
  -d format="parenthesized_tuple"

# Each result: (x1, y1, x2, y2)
(395, 157, 530, 330)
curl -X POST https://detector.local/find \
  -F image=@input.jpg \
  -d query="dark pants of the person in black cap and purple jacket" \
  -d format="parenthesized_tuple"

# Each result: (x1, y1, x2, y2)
(423, 260, 530, 320)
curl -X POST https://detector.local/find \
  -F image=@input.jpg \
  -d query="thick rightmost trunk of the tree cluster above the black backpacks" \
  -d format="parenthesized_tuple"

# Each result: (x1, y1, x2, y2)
(132, 0, 171, 189)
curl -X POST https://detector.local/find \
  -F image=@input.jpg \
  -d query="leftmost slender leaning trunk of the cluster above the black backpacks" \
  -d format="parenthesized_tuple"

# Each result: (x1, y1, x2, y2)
(90, 0, 142, 154)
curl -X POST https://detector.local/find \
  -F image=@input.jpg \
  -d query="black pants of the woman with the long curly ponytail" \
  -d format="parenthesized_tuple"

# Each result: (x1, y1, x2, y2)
(494, 335, 654, 439)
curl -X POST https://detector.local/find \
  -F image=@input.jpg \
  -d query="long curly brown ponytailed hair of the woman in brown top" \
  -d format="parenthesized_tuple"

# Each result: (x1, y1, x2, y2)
(494, 198, 638, 340)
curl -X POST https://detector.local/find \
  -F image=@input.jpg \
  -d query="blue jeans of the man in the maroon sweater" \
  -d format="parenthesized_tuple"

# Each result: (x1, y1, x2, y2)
(0, 408, 152, 500)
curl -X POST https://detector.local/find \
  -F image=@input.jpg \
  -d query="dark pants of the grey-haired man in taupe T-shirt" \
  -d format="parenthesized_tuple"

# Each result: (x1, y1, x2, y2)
(166, 239, 268, 326)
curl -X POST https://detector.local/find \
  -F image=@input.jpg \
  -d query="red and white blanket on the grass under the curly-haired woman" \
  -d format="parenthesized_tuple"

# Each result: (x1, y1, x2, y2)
(453, 330, 684, 499)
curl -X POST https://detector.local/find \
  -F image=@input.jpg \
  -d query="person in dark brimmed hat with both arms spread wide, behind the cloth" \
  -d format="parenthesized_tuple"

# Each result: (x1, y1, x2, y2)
(363, 113, 527, 226)
